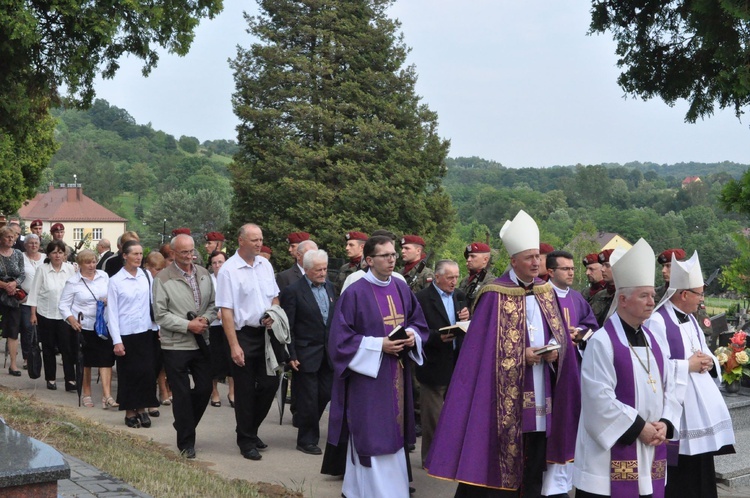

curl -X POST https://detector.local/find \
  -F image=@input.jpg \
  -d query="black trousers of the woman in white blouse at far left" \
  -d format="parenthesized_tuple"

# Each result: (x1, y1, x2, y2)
(36, 313, 77, 382)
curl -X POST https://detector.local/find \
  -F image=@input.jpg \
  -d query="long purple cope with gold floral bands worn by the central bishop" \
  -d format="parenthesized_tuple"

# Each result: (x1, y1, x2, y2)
(425, 273, 581, 490)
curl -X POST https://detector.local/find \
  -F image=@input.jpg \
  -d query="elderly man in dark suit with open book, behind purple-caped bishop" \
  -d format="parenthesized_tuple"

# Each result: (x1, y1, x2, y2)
(416, 259, 469, 466)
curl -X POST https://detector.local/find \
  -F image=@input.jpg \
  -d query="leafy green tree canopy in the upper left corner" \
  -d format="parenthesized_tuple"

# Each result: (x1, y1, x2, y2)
(0, 0, 222, 213)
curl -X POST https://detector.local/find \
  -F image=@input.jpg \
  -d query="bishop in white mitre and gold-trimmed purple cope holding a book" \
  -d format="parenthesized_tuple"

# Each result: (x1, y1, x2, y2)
(425, 211, 580, 497)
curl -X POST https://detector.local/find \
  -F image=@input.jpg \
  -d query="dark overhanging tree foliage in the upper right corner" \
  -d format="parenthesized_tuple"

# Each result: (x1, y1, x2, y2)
(591, 0, 750, 122)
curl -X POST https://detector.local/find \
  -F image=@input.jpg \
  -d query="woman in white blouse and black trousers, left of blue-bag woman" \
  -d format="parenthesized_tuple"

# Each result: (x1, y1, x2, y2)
(27, 240, 77, 392)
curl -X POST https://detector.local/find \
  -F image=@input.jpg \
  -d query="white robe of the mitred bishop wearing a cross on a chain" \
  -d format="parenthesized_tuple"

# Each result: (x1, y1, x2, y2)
(573, 313, 681, 495)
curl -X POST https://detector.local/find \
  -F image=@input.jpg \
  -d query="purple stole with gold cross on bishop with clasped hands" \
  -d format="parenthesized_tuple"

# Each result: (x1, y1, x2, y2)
(604, 319, 667, 498)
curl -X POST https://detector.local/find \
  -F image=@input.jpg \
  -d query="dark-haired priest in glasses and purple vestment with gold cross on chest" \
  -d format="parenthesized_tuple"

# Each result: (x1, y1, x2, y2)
(328, 236, 429, 498)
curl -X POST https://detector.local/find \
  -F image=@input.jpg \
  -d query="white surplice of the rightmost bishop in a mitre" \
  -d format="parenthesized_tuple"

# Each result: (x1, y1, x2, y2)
(646, 302, 734, 455)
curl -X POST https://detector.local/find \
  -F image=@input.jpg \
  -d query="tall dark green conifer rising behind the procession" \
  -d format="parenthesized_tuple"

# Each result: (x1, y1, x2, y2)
(231, 0, 453, 255)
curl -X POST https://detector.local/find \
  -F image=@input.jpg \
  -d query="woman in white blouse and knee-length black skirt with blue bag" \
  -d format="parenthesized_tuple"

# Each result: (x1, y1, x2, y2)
(59, 249, 118, 409)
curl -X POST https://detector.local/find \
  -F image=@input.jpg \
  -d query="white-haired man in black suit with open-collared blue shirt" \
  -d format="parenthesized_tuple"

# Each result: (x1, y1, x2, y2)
(281, 249, 335, 455)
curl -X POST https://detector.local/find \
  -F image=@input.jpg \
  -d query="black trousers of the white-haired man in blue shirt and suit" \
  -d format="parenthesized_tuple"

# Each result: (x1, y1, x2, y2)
(292, 359, 333, 445)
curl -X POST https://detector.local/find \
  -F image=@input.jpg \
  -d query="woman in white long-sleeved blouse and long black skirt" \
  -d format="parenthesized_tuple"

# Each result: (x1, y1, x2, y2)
(107, 240, 159, 427)
